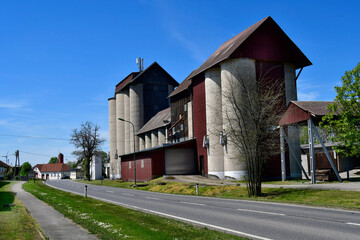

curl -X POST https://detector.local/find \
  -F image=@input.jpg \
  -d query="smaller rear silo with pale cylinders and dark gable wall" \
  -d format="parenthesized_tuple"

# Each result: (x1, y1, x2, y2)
(109, 62, 178, 179)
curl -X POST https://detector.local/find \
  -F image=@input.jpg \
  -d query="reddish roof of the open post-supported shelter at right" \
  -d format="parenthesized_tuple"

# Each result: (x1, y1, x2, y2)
(279, 101, 333, 126)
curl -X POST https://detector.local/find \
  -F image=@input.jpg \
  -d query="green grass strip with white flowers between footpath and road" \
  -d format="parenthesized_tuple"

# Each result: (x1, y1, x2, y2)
(23, 182, 248, 240)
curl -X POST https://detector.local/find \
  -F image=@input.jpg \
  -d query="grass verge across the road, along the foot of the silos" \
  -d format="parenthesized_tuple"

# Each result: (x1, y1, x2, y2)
(80, 178, 360, 211)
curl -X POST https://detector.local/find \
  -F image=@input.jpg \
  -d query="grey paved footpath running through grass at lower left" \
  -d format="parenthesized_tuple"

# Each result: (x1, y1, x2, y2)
(12, 182, 97, 240)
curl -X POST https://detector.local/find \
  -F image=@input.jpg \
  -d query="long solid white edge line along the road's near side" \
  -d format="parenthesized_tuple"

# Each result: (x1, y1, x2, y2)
(50, 185, 273, 240)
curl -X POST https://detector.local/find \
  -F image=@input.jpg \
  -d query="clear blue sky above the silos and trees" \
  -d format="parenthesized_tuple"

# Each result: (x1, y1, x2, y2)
(0, 0, 360, 168)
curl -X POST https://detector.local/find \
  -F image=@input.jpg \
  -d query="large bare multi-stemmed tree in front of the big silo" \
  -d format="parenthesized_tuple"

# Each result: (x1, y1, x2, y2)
(222, 67, 285, 196)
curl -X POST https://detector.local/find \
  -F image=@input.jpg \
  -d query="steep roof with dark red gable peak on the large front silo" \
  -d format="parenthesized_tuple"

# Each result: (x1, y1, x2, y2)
(169, 16, 312, 97)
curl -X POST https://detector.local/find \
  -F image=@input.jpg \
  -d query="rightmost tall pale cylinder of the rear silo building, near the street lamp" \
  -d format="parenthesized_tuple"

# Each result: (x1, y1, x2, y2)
(130, 83, 144, 152)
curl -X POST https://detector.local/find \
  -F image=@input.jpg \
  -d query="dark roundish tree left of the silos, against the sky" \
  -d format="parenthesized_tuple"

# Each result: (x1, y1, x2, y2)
(70, 122, 105, 181)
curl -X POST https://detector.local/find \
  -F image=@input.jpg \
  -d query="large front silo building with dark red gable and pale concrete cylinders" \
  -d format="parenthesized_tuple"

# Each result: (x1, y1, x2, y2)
(169, 17, 311, 179)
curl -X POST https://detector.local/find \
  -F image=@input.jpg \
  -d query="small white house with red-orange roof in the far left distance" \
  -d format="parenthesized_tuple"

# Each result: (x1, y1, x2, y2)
(33, 163, 71, 180)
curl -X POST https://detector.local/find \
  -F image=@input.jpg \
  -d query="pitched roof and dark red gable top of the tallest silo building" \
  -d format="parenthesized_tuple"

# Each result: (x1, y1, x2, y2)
(169, 16, 312, 97)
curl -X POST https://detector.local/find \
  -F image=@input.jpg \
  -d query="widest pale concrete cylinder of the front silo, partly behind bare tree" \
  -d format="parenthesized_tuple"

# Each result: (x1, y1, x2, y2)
(221, 58, 256, 179)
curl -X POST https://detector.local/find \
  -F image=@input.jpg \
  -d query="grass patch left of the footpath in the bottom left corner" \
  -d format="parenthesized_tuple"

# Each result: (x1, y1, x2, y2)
(0, 181, 42, 240)
